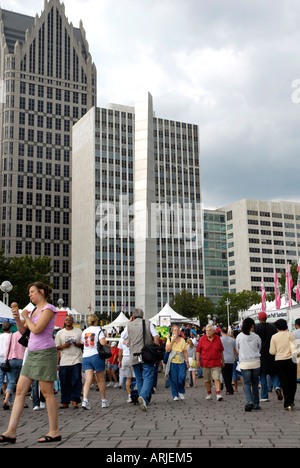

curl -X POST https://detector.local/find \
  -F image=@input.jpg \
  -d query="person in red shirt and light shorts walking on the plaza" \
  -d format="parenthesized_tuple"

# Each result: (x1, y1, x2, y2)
(196, 325, 225, 401)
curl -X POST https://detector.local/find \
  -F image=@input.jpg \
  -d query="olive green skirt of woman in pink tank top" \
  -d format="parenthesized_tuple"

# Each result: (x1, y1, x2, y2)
(21, 348, 57, 382)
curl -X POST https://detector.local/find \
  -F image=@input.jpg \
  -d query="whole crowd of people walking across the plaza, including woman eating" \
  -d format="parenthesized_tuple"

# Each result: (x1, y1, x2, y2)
(0, 283, 300, 444)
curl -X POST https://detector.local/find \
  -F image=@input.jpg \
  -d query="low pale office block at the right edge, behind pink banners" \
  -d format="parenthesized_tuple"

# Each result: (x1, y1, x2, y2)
(219, 199, 300, 292)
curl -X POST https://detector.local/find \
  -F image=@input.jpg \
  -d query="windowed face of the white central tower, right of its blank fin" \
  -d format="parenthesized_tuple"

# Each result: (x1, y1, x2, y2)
(154, 111, 205, 311)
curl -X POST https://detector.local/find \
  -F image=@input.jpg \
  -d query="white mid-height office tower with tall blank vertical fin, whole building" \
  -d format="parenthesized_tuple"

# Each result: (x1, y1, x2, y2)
(72, 91, 204, 318)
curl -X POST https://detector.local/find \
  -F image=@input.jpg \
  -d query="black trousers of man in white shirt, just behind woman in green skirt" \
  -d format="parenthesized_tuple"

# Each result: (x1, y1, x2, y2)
(59, 364, 82, 404)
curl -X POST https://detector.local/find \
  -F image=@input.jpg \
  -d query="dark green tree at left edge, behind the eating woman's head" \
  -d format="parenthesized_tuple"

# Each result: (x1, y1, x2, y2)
(0, 251, 52, 309)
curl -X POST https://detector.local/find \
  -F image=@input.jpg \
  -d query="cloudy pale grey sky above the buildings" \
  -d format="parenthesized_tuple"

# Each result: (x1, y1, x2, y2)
(0, 0, 300, 208)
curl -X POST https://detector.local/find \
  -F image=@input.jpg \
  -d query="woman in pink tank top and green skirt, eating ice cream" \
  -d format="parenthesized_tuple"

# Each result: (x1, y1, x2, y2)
(0, 282, 61, 444)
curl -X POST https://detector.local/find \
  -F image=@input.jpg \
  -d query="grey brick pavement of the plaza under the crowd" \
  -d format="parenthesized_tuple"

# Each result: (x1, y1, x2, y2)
(0, 374, 300, 450)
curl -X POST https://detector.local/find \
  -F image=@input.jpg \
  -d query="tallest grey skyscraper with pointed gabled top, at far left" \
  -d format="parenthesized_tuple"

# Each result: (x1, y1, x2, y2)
(0, 0, 96, 305)
